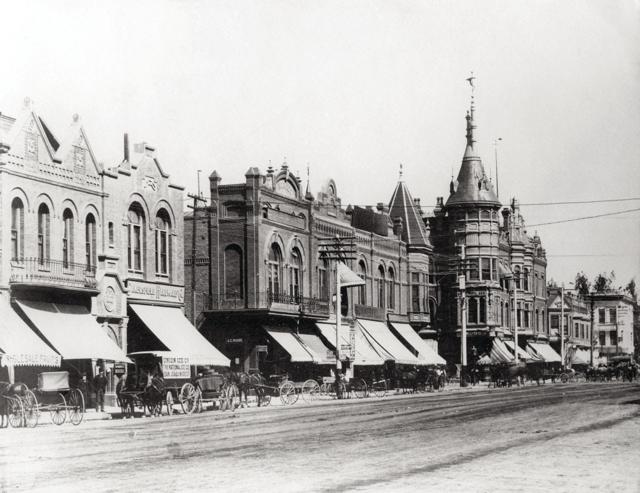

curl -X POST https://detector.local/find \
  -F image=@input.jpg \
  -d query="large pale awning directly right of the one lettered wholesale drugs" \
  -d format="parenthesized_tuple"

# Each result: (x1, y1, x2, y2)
(17, 300, 132, 363)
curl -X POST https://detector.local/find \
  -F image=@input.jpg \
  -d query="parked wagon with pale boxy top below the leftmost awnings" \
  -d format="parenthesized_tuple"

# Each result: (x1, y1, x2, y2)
(15, 371, 85, 428)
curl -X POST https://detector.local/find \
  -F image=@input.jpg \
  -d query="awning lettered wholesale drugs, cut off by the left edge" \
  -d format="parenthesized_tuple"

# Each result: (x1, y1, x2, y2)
(0, 300, 61, 366)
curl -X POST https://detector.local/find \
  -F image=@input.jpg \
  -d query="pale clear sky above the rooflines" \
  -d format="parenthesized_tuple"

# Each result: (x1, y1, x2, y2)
(0, 0, 640, 285)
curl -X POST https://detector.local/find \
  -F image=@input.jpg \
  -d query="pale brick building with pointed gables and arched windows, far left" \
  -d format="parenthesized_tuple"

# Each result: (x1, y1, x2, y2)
(0, 100, 226, 398)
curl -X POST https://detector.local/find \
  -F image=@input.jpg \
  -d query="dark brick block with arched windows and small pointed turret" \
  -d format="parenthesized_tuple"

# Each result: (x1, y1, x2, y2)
(185, 164, 439, 372)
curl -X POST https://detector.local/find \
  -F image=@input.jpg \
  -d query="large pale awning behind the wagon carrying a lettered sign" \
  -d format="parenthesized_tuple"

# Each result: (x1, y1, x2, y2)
(129, 304, 230, 366)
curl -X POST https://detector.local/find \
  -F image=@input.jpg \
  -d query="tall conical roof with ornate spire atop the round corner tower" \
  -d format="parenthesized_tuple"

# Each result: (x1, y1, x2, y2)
(445, 85, 502, 207)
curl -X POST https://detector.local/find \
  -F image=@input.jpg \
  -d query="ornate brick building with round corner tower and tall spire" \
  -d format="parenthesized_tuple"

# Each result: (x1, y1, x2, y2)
(429, 90, 549, 364)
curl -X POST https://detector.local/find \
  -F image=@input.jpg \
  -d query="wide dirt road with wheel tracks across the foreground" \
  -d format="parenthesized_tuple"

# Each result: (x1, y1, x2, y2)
(0, 383, 640, 492)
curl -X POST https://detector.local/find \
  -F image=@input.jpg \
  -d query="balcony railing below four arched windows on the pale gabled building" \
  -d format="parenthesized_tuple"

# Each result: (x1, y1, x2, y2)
(9, 258, 98, 289)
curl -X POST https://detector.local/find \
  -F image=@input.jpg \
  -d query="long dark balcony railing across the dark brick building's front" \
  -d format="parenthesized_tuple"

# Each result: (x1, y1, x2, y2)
(199, 291, 329, 316)
